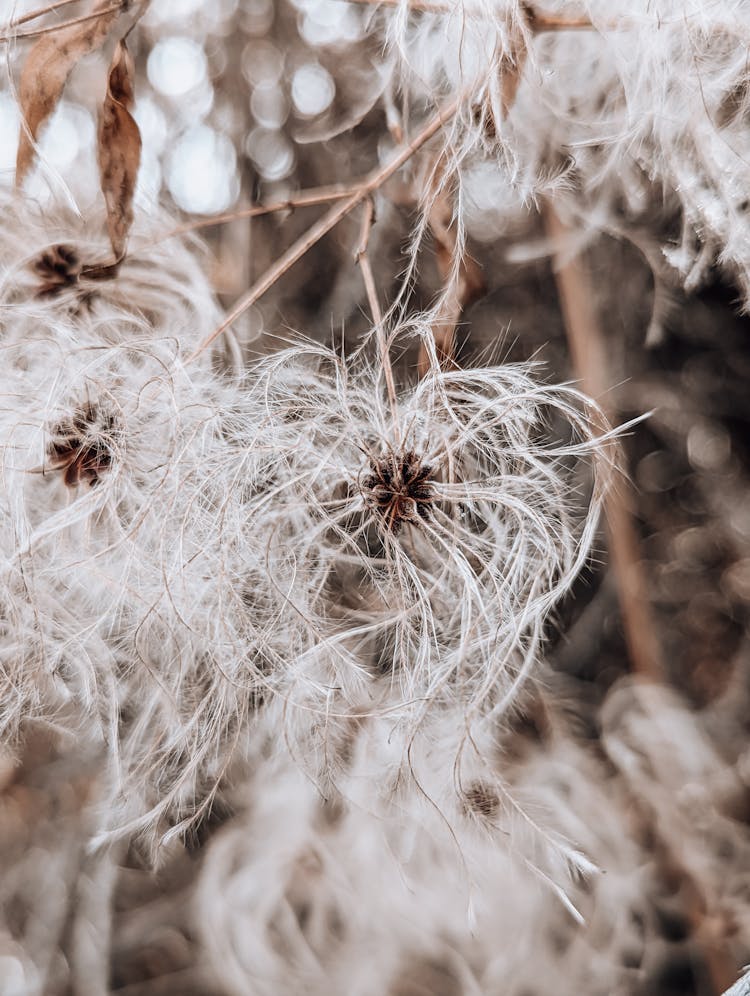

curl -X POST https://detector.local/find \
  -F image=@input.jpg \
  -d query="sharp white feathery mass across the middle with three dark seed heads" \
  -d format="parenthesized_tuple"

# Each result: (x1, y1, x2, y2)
(0, 185, 624, 848)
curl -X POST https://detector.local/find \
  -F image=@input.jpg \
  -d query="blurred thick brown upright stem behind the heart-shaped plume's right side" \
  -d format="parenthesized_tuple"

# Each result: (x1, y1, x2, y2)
(543, 201, 664, 680)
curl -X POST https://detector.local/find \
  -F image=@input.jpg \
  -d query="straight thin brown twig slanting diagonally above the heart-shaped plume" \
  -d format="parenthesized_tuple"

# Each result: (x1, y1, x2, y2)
(187, 95, 463, 363)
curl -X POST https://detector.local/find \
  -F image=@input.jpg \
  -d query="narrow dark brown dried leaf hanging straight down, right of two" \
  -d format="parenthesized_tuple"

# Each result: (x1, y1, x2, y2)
(99, 40, 141, 260)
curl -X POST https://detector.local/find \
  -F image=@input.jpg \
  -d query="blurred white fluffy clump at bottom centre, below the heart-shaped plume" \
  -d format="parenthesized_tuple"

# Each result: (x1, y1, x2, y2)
(193, 715, 652, 996)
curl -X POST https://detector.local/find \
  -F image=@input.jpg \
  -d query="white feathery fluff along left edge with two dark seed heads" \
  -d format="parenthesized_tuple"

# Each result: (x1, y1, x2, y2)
(0, 199, 260, 848)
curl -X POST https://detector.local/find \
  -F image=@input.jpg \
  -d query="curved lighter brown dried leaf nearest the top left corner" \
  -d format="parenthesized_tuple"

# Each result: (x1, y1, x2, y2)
(16, 0, 125, 187)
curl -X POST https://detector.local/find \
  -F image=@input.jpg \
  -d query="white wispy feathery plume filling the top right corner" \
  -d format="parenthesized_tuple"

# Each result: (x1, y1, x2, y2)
(373, 0, 750, 299)
